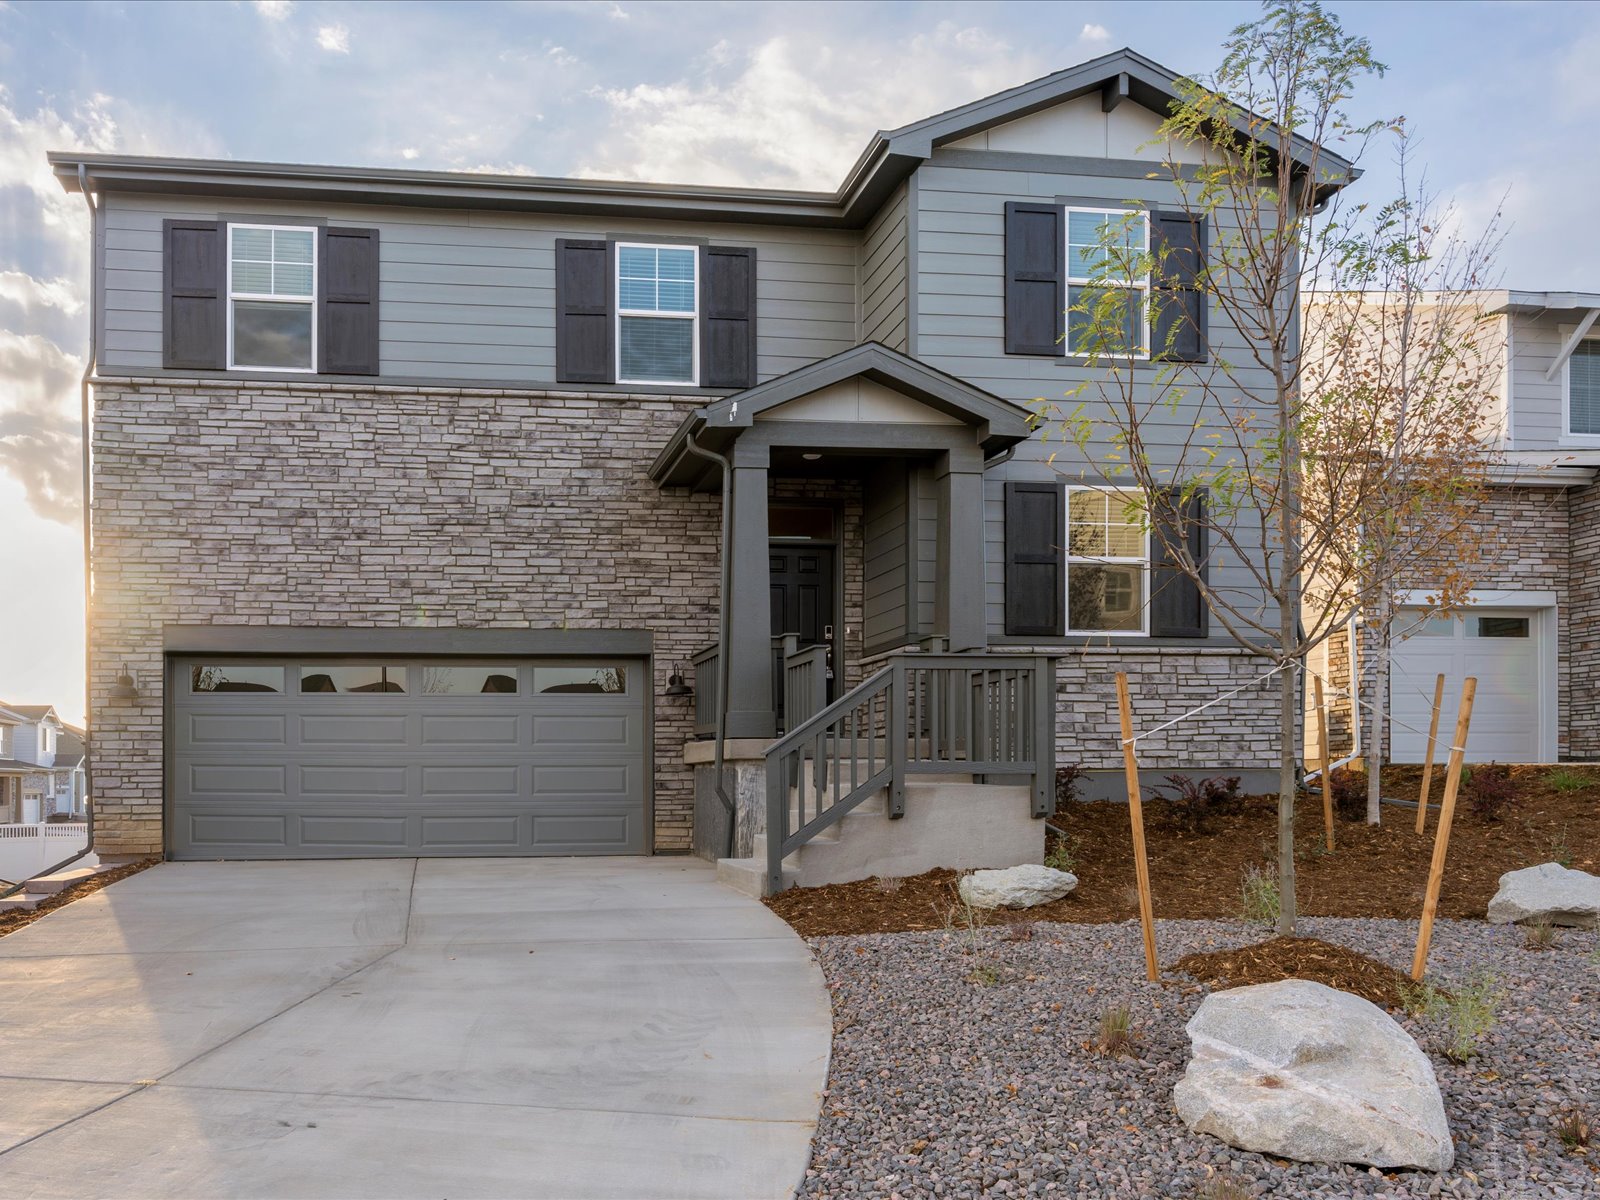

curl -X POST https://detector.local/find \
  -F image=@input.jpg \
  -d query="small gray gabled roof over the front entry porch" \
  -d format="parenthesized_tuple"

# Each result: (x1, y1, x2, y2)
(650, 342, 1032, 486)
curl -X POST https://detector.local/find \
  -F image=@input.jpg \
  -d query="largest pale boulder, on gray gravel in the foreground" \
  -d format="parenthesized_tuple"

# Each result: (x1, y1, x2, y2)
(1173, 979, 1456, 1171)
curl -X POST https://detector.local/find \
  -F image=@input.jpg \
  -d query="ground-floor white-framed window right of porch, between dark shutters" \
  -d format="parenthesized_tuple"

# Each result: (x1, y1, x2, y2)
(1067, 488, 1150, 635)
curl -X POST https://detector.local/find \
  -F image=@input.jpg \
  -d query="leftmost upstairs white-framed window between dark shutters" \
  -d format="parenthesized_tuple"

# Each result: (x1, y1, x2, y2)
(227, 224, 317, 371)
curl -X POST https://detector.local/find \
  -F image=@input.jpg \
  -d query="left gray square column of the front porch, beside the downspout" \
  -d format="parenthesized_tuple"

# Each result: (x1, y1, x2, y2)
(722, 446, 778, 738)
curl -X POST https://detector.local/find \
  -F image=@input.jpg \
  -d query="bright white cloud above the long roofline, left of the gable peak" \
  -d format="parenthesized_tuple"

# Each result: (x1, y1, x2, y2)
(576, 22, 1043, 189)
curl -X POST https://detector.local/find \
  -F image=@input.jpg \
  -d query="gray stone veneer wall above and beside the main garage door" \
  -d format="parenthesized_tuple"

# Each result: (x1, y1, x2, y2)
(90, 379, 718, 854)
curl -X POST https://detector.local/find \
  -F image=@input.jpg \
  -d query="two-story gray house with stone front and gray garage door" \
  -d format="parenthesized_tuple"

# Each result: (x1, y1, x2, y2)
(51, 51, 1339, 876)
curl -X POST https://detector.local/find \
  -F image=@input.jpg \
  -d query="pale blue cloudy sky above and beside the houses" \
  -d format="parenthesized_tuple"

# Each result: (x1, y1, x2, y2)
(0, 0, 1600, 718)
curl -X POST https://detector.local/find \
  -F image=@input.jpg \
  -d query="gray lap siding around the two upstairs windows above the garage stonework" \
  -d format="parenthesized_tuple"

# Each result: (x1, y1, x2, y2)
(101, 192, 861, 384)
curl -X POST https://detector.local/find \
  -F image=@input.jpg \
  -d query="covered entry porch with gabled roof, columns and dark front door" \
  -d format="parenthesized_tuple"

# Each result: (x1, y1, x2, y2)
(651, 344, 1029, 741)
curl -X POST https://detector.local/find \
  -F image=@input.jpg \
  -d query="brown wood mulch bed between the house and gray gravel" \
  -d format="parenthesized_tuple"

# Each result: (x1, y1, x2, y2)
(766, 766, 1600, 938)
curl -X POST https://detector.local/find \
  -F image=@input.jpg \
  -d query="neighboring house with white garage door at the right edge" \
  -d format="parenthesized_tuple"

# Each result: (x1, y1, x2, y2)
(1314, 291, 1600, 763)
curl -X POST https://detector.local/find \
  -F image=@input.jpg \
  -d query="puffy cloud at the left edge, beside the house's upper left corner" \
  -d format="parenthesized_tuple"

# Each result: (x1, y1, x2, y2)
(0, 330, 83, 523)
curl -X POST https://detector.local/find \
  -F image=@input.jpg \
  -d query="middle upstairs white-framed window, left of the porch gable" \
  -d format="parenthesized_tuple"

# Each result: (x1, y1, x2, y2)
(616, 242, 699, 386)
